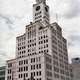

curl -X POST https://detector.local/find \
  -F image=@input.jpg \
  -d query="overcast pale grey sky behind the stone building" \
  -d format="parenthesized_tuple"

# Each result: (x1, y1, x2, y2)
(0, 0, 80, 66)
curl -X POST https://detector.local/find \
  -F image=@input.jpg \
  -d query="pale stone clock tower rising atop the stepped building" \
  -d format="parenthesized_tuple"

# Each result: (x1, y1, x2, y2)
(33, 0, 49, 26)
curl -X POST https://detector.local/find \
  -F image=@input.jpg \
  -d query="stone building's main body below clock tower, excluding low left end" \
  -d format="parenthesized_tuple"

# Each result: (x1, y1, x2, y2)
(7, 22, 71, 80)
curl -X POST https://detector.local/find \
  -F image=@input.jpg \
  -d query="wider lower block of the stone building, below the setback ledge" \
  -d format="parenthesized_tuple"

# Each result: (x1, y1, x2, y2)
(6, 54, 72, 80)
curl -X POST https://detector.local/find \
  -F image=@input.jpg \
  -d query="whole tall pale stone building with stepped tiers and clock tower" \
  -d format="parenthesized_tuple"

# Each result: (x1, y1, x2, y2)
(6, 0, 72, 80)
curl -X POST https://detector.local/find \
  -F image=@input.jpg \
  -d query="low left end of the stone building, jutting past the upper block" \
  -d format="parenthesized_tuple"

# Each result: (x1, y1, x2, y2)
(5, 59, 17, 80)
